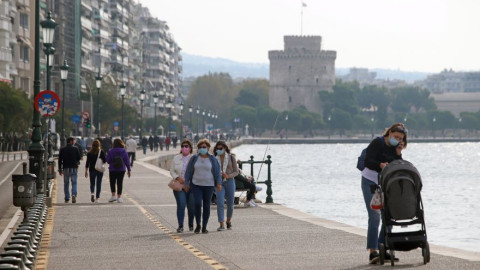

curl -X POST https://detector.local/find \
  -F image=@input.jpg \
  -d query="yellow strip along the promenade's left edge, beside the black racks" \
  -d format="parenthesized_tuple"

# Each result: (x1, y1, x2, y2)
(35, 179, 57, 270)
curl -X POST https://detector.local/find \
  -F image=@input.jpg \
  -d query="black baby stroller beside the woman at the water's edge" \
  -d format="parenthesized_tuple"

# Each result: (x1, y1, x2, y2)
(379, 160, 430, 266)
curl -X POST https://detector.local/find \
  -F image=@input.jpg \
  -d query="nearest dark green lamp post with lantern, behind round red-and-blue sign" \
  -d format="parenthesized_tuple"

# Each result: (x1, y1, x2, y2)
(28, 8, 57, 194)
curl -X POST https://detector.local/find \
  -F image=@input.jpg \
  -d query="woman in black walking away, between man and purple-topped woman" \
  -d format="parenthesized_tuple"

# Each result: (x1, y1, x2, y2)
(85, 140, 107, 202)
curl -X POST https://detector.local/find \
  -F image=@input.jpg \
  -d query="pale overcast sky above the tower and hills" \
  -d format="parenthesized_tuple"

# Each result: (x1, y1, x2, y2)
(137, 0, 480, 73)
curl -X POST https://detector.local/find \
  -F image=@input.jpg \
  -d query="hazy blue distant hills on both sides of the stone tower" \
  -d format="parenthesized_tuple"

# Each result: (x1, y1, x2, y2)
(182, 53, 430, 83)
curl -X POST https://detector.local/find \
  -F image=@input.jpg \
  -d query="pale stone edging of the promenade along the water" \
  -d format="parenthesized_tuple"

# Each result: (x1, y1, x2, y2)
(259, 204, 480, 261)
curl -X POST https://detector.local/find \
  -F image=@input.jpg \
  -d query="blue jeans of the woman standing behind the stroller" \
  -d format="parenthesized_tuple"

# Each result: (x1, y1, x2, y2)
(362, 177, 385, 249)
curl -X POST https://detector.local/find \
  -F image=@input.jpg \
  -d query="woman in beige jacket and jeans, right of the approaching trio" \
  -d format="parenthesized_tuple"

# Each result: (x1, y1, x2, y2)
(213, 141, 239, 231)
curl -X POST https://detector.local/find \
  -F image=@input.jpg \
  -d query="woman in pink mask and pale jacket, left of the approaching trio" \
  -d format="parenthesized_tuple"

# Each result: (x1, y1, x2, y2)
(170, 140, 195, 233)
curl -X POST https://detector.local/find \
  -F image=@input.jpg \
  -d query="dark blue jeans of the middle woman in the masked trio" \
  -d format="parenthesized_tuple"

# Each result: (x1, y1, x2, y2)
(191, 183, 214, 228)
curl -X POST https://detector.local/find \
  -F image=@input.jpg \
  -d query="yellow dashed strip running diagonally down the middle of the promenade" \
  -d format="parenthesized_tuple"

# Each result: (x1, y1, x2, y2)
(124, 194, 228, 270)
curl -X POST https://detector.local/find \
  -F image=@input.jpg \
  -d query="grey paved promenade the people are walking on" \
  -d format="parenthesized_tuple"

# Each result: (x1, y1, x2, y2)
(2, 148, 480, 270)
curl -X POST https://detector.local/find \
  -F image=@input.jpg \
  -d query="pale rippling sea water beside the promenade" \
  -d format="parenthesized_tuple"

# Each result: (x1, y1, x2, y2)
(234, 143, 480, 252)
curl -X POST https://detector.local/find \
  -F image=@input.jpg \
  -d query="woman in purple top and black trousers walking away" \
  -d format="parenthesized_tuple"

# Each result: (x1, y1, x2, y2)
(107, 139, 131, 203)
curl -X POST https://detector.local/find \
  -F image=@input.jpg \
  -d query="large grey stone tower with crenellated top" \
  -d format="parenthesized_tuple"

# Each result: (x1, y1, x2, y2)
(268, 36, 337, 113)
